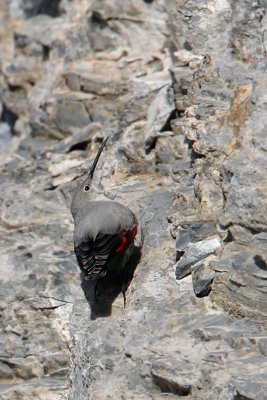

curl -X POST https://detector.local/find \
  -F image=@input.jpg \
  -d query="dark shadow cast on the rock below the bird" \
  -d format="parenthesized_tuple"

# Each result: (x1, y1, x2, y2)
(81, 246, 142, 320)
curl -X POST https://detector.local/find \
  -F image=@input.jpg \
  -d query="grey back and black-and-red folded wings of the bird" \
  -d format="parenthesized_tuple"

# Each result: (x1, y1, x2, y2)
(74, 200, 137, 279)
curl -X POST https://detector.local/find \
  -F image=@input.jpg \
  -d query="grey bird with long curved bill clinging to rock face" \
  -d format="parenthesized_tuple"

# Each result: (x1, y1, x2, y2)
(71, 136, 138, 307)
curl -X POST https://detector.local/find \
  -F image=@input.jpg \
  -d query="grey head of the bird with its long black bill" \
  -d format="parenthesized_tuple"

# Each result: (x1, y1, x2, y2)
(71, 136, 109, 218)
